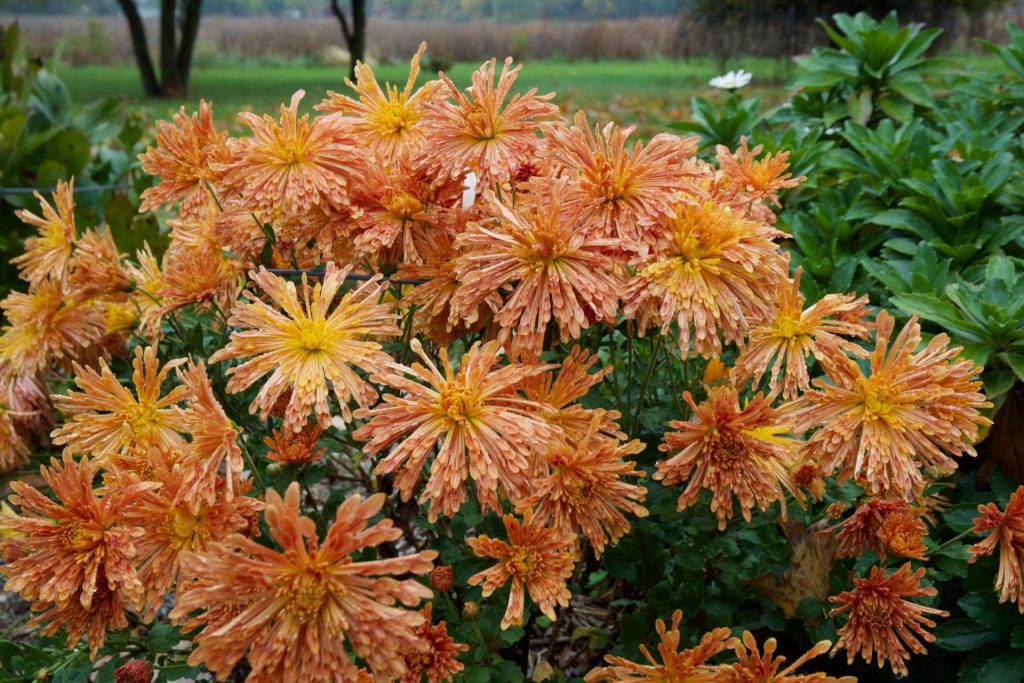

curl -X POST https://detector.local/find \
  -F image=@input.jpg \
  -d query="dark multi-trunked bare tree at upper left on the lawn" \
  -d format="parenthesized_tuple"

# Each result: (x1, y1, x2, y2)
(118, 0, 203, 97)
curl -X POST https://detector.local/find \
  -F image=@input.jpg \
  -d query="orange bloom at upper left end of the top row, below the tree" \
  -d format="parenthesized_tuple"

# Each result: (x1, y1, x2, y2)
(138, 99, 230, 215)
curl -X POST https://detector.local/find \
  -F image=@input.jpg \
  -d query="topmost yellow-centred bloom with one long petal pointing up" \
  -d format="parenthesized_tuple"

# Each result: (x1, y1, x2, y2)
(315, 43, 441, 159)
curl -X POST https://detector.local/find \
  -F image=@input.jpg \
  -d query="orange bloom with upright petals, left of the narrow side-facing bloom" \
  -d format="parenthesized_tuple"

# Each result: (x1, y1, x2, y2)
(53, 346, 187, 461)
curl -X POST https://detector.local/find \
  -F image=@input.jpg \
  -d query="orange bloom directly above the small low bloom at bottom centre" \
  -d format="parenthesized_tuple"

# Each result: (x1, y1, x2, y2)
(519, 417, 647, 557)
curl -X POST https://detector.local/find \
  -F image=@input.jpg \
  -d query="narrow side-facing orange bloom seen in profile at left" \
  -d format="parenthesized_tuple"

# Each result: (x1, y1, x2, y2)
(178, 360, 243, 503)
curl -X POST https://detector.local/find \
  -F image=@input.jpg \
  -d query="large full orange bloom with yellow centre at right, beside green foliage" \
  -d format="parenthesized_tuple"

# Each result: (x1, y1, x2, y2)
(787, 311, 991, 498)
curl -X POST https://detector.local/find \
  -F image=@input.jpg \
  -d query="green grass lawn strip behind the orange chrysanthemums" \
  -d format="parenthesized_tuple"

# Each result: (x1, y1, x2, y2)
(59, 58, 793, 135)
